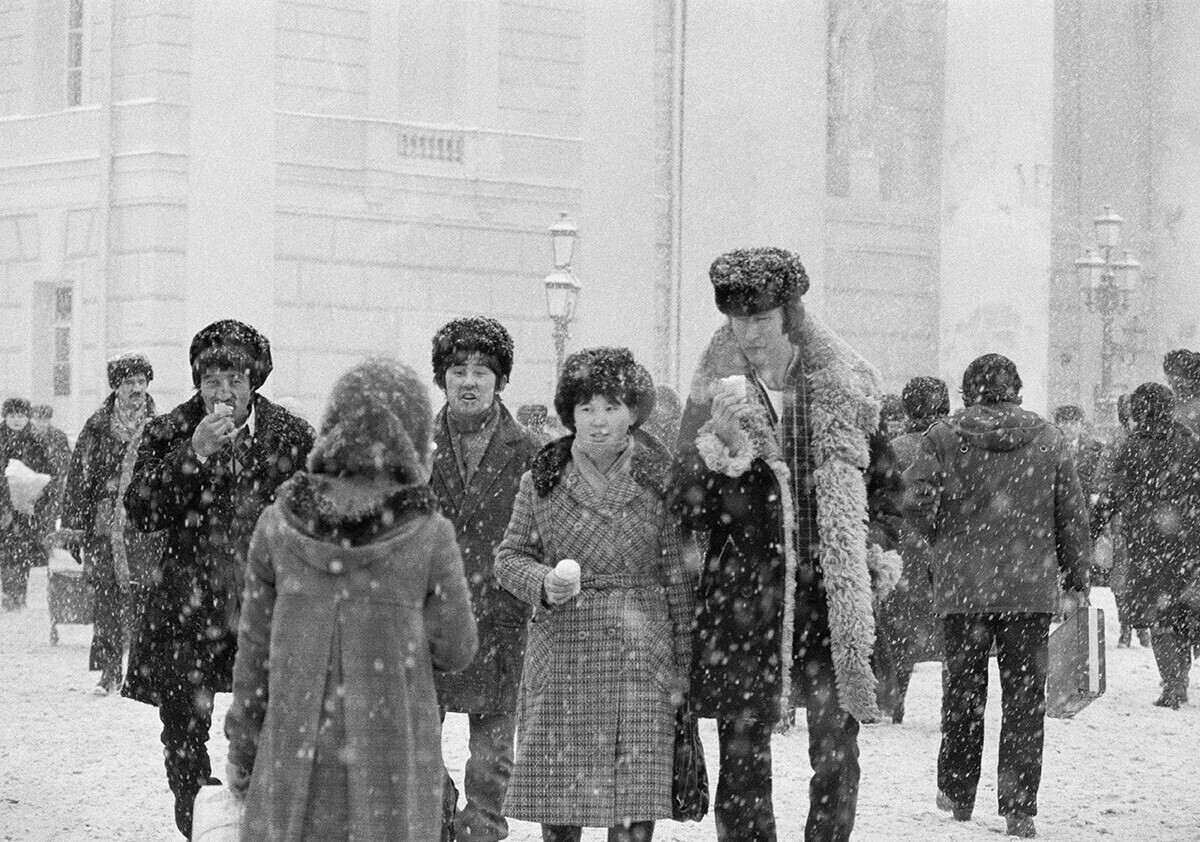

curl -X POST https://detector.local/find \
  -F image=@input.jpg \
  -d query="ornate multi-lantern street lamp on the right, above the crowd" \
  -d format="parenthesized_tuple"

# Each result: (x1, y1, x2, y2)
(1075, 205, 1141, 423)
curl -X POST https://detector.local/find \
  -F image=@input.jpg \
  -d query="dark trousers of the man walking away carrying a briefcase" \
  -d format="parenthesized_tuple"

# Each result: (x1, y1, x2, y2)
(937, 613, 1050, 816)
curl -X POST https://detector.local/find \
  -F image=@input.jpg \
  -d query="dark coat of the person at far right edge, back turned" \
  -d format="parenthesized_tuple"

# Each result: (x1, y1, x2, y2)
(1093, 423, 1200, 629)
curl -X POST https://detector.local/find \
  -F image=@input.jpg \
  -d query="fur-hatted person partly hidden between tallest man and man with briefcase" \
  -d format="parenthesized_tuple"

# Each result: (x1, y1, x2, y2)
(872, 377, 950, 724)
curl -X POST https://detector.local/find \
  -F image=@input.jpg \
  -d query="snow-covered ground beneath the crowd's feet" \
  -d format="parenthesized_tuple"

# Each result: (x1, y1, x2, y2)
(0, 569, 1200, 842)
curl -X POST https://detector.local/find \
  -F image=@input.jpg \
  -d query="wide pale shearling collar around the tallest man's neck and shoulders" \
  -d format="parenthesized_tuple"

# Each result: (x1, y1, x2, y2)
(691, 312, 882, 446)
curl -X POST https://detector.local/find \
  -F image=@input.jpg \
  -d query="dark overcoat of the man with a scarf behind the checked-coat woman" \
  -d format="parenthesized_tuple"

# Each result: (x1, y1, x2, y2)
(430, 403, 538, 714)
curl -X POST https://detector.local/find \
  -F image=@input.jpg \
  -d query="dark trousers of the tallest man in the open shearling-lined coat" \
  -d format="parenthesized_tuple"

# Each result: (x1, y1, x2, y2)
(713, 597, 860, 842)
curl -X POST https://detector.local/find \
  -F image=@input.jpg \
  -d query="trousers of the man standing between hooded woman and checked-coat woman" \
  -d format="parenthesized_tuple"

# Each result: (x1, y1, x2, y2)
(442, 711, 517, 842)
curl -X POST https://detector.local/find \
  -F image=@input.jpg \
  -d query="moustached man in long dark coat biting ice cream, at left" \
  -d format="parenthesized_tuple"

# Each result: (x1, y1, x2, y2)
(121, 319, 313, 836)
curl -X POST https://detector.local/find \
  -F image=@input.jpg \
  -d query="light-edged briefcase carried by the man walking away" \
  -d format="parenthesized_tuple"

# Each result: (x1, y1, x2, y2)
(1046, 606, 1105, 720)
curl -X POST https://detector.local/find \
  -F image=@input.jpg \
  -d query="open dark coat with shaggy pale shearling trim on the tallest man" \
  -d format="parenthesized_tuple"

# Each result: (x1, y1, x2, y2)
(673, 314, 902, 722)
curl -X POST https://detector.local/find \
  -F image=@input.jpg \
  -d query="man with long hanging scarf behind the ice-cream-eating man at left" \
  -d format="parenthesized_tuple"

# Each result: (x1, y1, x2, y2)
(60, 354, 164, 696)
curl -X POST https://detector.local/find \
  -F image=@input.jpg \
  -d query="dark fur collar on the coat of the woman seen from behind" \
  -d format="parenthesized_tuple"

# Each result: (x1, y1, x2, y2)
(278, 473, 438, 546)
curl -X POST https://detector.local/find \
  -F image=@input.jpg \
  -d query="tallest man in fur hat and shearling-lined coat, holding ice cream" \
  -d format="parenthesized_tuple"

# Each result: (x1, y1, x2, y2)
(676, 248, 901, 842)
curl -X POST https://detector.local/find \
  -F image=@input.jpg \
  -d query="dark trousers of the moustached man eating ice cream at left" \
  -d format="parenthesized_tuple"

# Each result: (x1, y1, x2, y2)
(158, 687, 212, 838)
